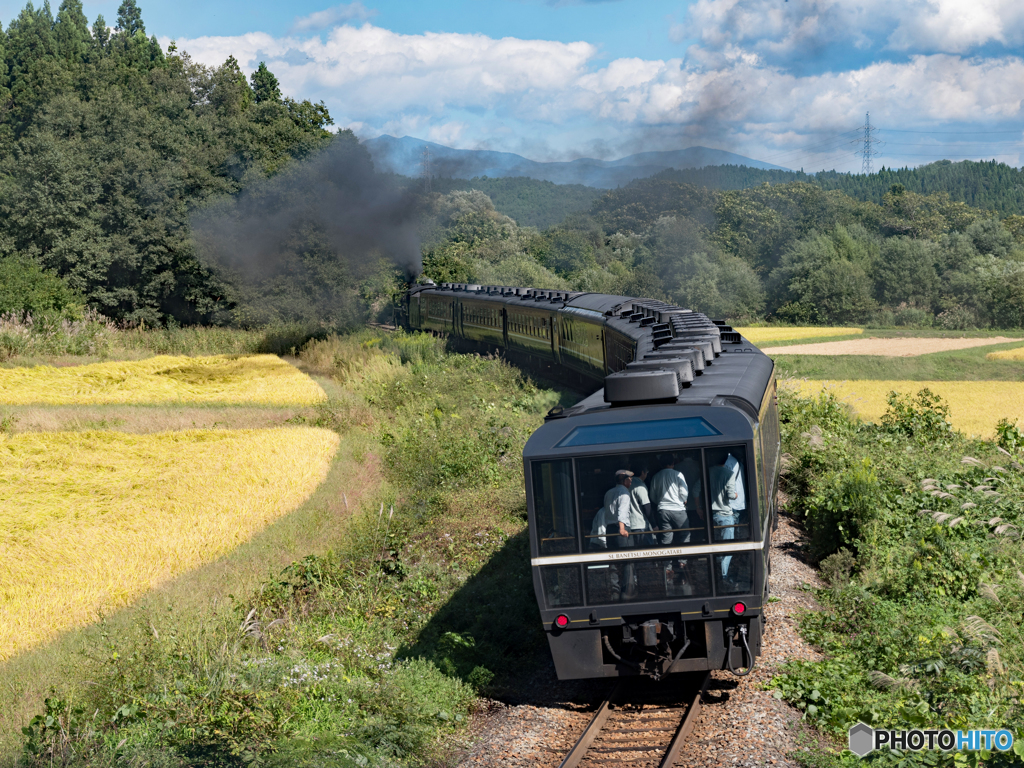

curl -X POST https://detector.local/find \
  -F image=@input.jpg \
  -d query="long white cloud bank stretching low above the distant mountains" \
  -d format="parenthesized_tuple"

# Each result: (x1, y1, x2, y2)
(167, 22, 1024, 167)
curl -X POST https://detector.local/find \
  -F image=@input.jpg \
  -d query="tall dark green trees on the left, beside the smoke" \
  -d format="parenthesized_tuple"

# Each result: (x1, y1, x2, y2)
(0, 0, 335, 323)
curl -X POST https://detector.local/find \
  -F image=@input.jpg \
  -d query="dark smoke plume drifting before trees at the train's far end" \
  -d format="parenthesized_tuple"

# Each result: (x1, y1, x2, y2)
(191, 131, 421, 327)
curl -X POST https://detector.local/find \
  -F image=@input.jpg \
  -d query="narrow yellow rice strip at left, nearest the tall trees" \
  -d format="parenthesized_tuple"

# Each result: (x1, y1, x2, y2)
(0, 354, 327, 406)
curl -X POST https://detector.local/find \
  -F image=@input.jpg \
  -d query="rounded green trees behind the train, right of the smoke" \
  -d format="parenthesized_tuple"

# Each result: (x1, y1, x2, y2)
(424, 180, 1024, 330)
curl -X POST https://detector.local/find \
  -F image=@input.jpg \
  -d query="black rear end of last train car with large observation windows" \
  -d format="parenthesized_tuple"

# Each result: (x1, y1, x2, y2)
(524, 397, 771, 680)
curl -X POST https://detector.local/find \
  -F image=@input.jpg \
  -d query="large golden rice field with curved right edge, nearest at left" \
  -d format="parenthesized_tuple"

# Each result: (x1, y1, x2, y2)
(0, 427, 339, 659)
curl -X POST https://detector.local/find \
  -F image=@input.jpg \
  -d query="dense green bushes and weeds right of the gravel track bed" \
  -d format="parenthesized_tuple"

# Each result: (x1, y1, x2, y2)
(773, 390, 1024, 766)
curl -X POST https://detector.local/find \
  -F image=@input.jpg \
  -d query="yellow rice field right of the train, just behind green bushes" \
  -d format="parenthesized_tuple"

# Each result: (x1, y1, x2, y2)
(786, 379, 1024, 437)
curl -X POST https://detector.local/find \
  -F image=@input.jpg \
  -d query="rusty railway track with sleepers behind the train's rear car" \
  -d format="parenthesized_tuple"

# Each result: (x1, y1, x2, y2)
(559, 672, 711, 768)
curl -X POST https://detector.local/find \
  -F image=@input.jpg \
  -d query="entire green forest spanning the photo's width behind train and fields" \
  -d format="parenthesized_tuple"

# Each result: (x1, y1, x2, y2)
(6, 0, 1024, 329)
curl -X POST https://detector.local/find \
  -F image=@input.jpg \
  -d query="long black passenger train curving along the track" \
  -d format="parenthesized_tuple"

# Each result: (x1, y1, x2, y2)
(406, 281, 780, 680)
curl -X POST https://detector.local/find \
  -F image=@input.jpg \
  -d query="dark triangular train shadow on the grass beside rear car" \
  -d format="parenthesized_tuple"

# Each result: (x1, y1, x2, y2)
(399, 530, 555, 701)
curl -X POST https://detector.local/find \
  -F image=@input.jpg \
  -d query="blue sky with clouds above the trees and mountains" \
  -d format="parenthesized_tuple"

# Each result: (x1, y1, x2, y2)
(9, 0, 1024, 172)
